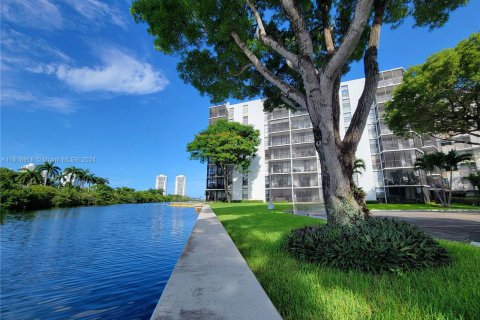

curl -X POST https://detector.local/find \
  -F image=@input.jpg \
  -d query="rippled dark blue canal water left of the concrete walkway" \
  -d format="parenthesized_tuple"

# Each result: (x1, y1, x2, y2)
(0, 204, 197, 320)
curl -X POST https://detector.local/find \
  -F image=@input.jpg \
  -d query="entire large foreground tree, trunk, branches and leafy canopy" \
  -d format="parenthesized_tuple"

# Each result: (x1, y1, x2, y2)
(130, 0, 468, 224)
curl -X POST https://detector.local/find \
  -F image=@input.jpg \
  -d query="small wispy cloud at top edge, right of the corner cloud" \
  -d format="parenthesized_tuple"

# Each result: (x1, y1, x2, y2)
(65, 0, 127, 29)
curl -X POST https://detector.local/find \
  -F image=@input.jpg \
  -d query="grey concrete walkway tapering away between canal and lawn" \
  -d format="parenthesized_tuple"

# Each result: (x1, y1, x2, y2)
(151, 205, 281, 320)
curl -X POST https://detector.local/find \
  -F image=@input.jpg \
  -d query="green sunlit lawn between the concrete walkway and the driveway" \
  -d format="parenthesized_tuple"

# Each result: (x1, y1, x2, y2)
(212, 203, 480, 320)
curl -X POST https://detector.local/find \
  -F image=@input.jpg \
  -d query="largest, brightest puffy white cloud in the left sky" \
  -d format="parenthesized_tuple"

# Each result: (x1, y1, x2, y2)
(40, 49, 169, 95)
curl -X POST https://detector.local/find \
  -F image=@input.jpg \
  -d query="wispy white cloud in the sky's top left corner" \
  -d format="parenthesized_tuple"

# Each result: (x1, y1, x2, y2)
(0, 0, 64, 30)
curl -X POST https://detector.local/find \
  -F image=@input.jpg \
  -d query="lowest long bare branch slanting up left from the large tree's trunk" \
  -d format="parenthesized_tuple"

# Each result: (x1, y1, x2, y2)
(230, 31, 307, 109)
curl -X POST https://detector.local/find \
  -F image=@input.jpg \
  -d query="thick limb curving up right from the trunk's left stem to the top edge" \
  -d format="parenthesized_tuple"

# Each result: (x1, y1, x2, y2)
(324, 0, 373, 78)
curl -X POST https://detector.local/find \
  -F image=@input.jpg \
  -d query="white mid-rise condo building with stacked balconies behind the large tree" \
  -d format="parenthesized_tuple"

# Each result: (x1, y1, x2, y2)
(206, 68, 480, 203)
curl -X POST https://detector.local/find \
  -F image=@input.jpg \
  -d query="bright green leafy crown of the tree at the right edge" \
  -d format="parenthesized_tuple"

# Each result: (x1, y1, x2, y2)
(385, 32, 480, 137)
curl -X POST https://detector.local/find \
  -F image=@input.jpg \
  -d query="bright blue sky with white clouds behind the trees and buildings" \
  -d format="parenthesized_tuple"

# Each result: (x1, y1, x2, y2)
(0, 0, 480, 196)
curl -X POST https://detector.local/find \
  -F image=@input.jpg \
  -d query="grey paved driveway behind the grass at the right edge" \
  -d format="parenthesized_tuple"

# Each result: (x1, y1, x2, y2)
(372, 211, 480, 242)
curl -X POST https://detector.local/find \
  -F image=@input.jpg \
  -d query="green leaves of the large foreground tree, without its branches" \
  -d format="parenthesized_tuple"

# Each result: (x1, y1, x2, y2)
(130, 0, 468, 110)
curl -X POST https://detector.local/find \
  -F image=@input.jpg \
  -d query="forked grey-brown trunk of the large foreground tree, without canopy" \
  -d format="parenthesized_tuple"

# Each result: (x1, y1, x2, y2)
(304, 47, 378, 225)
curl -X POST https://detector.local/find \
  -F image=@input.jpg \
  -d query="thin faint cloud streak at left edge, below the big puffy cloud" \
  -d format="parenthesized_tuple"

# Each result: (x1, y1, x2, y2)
(0, 88, 75, 114)
